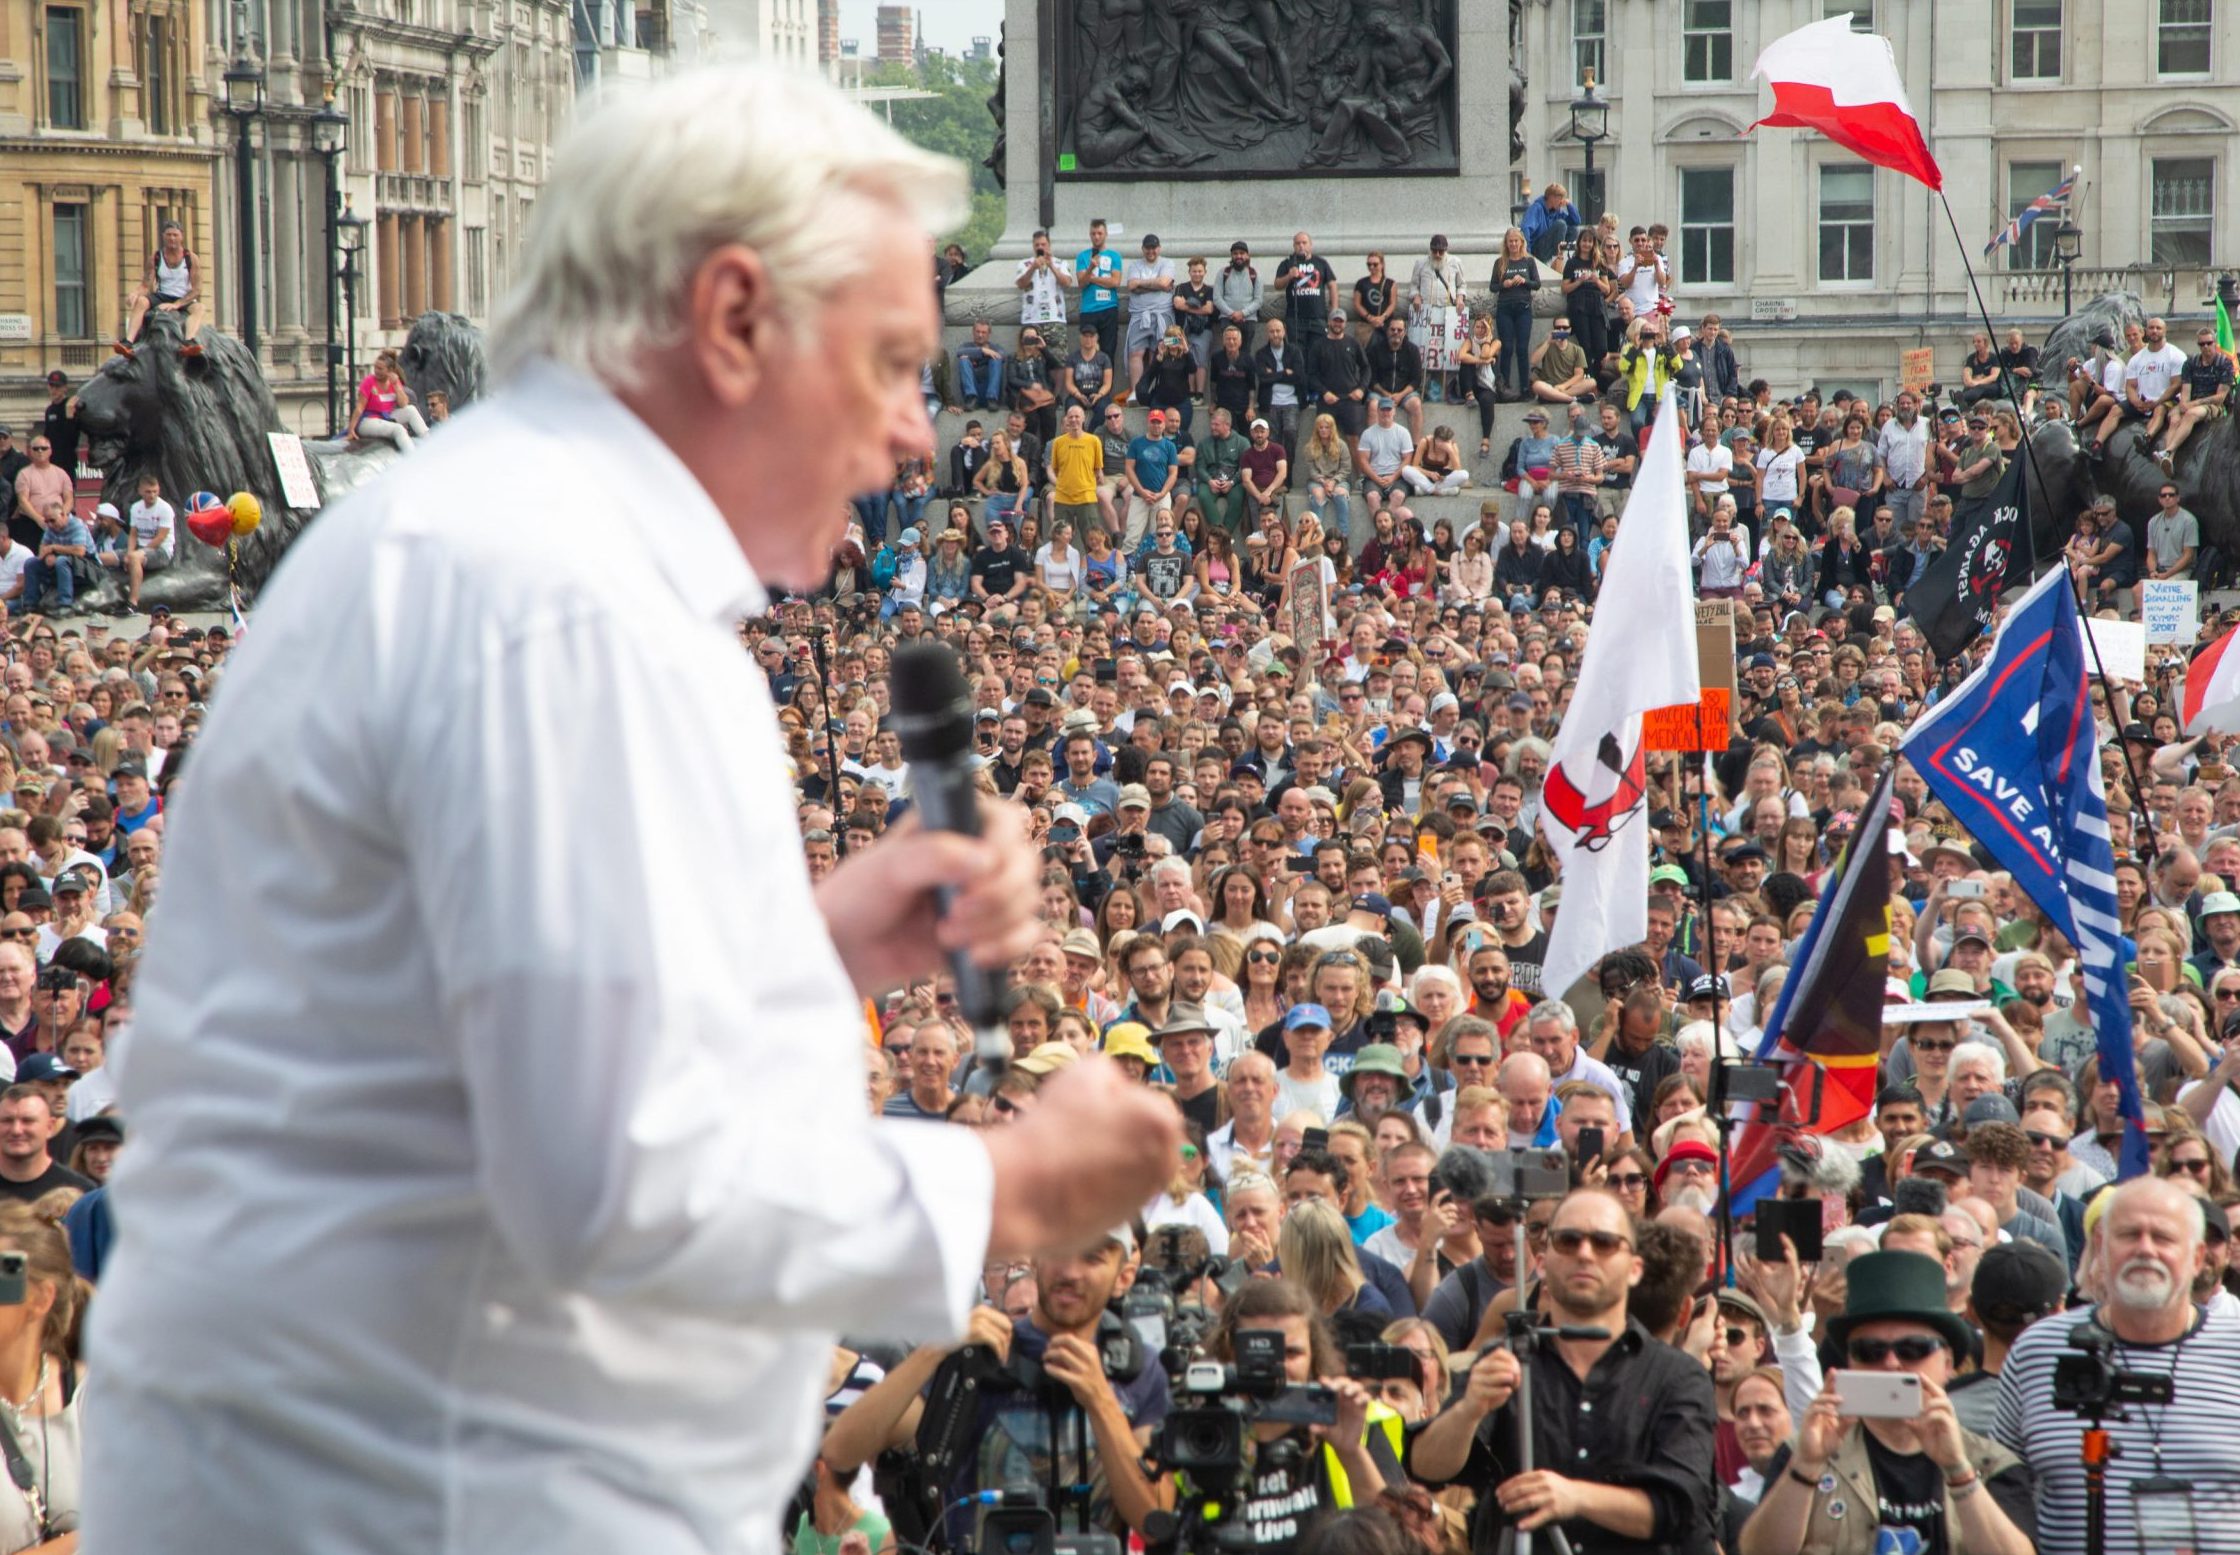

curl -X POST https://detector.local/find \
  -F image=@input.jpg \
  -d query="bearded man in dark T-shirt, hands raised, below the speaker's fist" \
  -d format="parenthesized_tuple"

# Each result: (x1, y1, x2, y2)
(822, 1226, 1169, 1544)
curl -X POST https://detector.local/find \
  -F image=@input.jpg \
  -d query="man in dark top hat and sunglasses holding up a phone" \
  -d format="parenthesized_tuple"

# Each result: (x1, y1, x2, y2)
(1736, 1253, 2036, 1555)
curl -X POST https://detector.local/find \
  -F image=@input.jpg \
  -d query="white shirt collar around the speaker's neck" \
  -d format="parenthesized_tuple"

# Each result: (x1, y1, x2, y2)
(515, 361, 771, 625)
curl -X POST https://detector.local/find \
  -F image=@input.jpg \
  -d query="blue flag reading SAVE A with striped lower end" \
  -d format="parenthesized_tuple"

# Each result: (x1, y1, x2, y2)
(1902, 567, 2148, 1176)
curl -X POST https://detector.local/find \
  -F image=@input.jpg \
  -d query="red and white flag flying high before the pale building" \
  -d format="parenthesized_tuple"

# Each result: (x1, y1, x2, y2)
(1749, 16, 1944, 190)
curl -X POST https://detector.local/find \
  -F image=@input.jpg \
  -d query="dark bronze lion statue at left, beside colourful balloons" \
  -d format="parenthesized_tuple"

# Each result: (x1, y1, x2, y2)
(78, 311, 302, 609)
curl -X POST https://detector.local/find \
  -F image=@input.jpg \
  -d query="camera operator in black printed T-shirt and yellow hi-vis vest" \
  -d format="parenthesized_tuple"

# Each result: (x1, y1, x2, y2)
(1207, 1279, 1407, 1551)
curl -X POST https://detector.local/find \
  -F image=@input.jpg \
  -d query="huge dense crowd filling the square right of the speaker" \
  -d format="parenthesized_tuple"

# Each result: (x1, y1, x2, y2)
(788, 210, 2240, 1555)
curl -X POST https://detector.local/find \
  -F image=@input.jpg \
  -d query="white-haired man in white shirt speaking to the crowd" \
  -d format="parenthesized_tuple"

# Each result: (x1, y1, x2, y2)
(83, 67, 1178, 1555)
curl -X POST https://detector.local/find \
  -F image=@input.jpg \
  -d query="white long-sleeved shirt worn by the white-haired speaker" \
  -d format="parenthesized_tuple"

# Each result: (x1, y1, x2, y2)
(83, 365, 992, 1555)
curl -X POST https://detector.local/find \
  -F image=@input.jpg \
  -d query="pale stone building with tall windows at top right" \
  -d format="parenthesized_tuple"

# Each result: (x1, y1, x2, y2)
(1516, 0, 2240, 401)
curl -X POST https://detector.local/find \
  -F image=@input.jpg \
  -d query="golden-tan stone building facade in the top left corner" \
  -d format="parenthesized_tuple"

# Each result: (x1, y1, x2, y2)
(0, 0, 224, 392)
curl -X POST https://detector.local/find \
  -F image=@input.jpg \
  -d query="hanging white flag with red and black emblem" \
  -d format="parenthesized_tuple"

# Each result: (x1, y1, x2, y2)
(1539, 388, 1702, 999)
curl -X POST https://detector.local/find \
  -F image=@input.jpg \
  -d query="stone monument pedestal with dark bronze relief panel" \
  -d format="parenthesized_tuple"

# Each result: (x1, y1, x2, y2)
(948, 0, 1510, 329)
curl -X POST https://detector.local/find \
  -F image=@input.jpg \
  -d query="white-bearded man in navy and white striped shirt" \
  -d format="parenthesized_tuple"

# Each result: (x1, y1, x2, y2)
(1998, 1176, 2240, 1555)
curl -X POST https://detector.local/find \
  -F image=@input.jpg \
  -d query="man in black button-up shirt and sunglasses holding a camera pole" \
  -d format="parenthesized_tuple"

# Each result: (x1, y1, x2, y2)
(1407, 1188, 1718, 1555)
